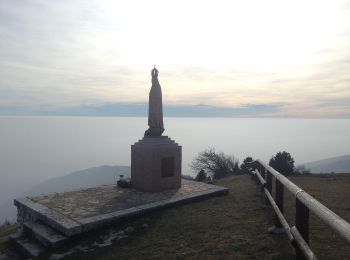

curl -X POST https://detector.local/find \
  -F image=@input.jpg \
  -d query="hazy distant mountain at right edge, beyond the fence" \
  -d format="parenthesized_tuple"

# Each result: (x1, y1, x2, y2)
(303, 155, 350, 173)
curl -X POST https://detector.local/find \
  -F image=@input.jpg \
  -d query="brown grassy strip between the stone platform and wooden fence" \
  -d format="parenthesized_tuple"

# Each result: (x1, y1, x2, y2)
(43, 176, 293, 259)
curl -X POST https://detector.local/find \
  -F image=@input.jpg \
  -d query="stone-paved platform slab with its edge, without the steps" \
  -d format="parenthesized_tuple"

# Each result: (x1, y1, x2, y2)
(15, 180, 228, 237)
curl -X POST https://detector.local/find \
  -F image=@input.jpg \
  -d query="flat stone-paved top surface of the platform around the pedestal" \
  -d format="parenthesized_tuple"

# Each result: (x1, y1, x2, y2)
(29, 180, 227, 222)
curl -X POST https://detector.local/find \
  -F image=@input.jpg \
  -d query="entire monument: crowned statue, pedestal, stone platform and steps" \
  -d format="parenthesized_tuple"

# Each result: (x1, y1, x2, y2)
(7, 68, 228, 258)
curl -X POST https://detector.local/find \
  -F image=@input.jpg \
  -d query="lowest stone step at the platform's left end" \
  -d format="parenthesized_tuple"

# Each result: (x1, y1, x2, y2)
(9, 231, 44, 258)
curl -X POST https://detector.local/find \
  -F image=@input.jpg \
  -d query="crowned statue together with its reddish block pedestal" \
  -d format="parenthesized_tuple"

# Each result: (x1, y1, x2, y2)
(131, 67, 182, 192)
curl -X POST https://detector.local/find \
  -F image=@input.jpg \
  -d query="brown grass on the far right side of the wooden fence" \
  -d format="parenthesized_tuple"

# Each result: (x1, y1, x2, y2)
(285, 174, 350, 260)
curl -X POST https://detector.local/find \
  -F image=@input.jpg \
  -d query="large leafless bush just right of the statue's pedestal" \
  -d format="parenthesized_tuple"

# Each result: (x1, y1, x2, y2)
(190, 148, 240, 179)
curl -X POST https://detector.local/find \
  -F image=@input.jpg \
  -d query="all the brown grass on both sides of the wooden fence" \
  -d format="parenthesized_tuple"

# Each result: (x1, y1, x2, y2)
(0, 175, 350, 260)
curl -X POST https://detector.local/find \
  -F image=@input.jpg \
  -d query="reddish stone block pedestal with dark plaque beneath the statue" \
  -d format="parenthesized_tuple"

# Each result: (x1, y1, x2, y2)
(131, 136, 182, 192)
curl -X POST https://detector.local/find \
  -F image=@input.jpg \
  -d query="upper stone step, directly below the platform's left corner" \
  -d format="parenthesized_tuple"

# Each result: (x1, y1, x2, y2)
(23, 222, 67, 247)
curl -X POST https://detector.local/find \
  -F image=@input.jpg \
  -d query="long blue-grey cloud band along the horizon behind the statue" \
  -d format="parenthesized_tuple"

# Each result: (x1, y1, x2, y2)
(0, 102, 282, 117)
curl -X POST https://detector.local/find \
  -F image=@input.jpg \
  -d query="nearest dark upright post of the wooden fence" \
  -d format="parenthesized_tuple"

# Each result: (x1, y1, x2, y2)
(295, 198, 309, 260)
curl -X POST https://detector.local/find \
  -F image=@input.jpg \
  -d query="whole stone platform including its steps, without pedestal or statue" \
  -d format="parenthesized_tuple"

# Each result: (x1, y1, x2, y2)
(12, 180, 228, 258)
